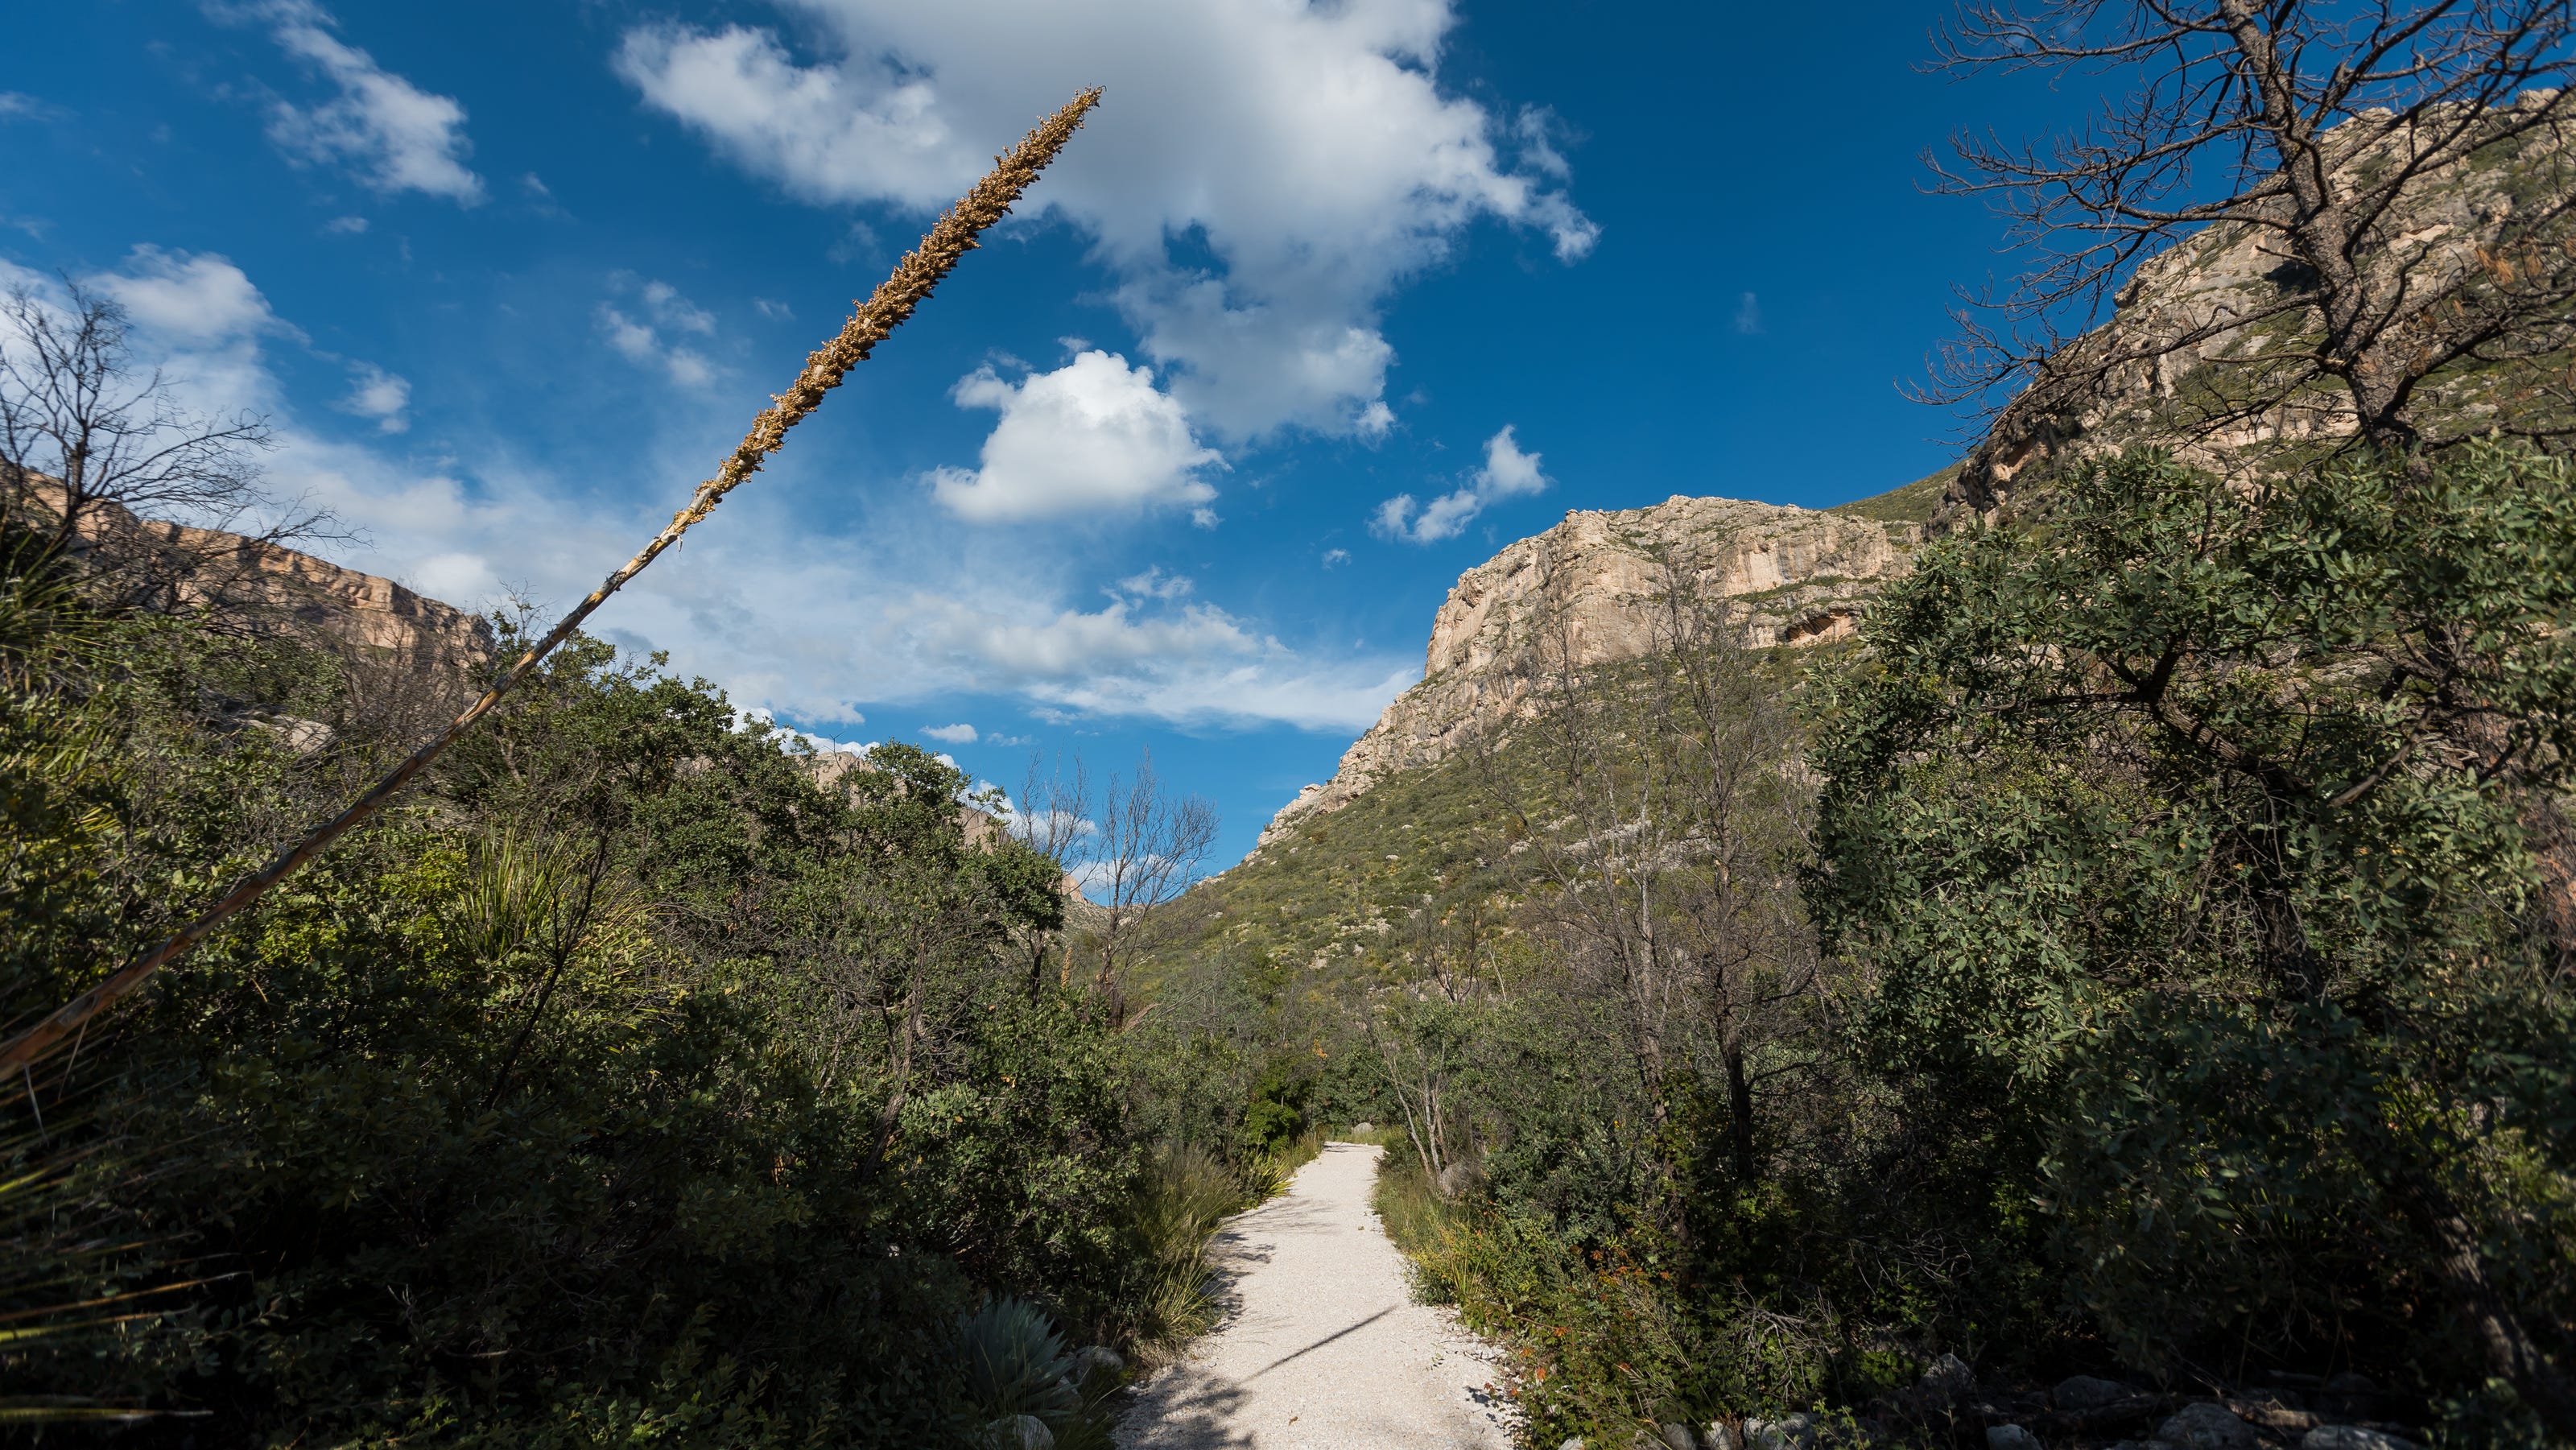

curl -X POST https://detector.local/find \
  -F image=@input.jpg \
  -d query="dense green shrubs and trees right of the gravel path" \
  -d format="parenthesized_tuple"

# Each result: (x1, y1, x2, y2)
(1205, 445, 2576, 1445)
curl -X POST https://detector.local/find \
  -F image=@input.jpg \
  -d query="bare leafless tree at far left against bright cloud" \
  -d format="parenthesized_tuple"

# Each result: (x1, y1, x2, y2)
(0, 281, 330, 597)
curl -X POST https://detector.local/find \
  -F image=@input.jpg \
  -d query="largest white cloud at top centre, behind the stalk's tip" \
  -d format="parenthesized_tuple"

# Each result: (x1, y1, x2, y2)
(616, 0, 1597, 438)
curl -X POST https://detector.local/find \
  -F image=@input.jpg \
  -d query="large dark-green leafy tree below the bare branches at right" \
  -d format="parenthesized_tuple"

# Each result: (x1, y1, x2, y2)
(1808, 445, 2576, 1390)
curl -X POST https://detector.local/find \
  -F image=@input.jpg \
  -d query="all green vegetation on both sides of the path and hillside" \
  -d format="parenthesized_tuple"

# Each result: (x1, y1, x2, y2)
(20, 448, 2576, 1445)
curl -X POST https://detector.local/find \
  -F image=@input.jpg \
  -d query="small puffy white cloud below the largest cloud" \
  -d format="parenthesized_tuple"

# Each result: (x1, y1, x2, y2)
(930, 350, 1224, 523)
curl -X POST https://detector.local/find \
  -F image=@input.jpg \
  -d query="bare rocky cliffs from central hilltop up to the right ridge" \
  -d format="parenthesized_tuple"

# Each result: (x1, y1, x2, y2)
(1260, 105, 2576, 845)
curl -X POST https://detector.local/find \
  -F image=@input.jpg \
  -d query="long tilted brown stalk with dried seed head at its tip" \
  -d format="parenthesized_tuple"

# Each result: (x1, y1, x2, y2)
(0, 85, 1100, 1079)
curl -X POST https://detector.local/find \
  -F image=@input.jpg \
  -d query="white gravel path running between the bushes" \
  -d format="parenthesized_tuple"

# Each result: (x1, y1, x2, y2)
(1118, 1143, 1512, 1450)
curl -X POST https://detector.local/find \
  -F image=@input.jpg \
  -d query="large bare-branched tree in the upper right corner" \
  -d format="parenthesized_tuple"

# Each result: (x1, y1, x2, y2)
(1924, 0, 2576, 507)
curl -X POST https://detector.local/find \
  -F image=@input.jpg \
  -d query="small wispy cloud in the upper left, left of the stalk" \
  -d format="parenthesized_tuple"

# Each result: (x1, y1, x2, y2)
(234, 0, 485, 206)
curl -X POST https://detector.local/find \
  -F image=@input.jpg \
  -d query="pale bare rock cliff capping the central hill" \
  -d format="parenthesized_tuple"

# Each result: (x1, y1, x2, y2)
(1260, 494, 1922, 845)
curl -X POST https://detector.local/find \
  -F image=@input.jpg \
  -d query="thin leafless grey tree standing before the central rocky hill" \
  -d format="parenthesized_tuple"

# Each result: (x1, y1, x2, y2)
(1476, 551, 1816, 1205)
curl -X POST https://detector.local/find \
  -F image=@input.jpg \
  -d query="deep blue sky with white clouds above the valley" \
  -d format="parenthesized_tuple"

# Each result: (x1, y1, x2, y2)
(0, 0, 2046, 863)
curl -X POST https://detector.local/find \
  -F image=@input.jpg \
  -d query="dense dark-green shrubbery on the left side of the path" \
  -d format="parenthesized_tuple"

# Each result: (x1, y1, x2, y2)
(0, 538, 1275, 1445)
